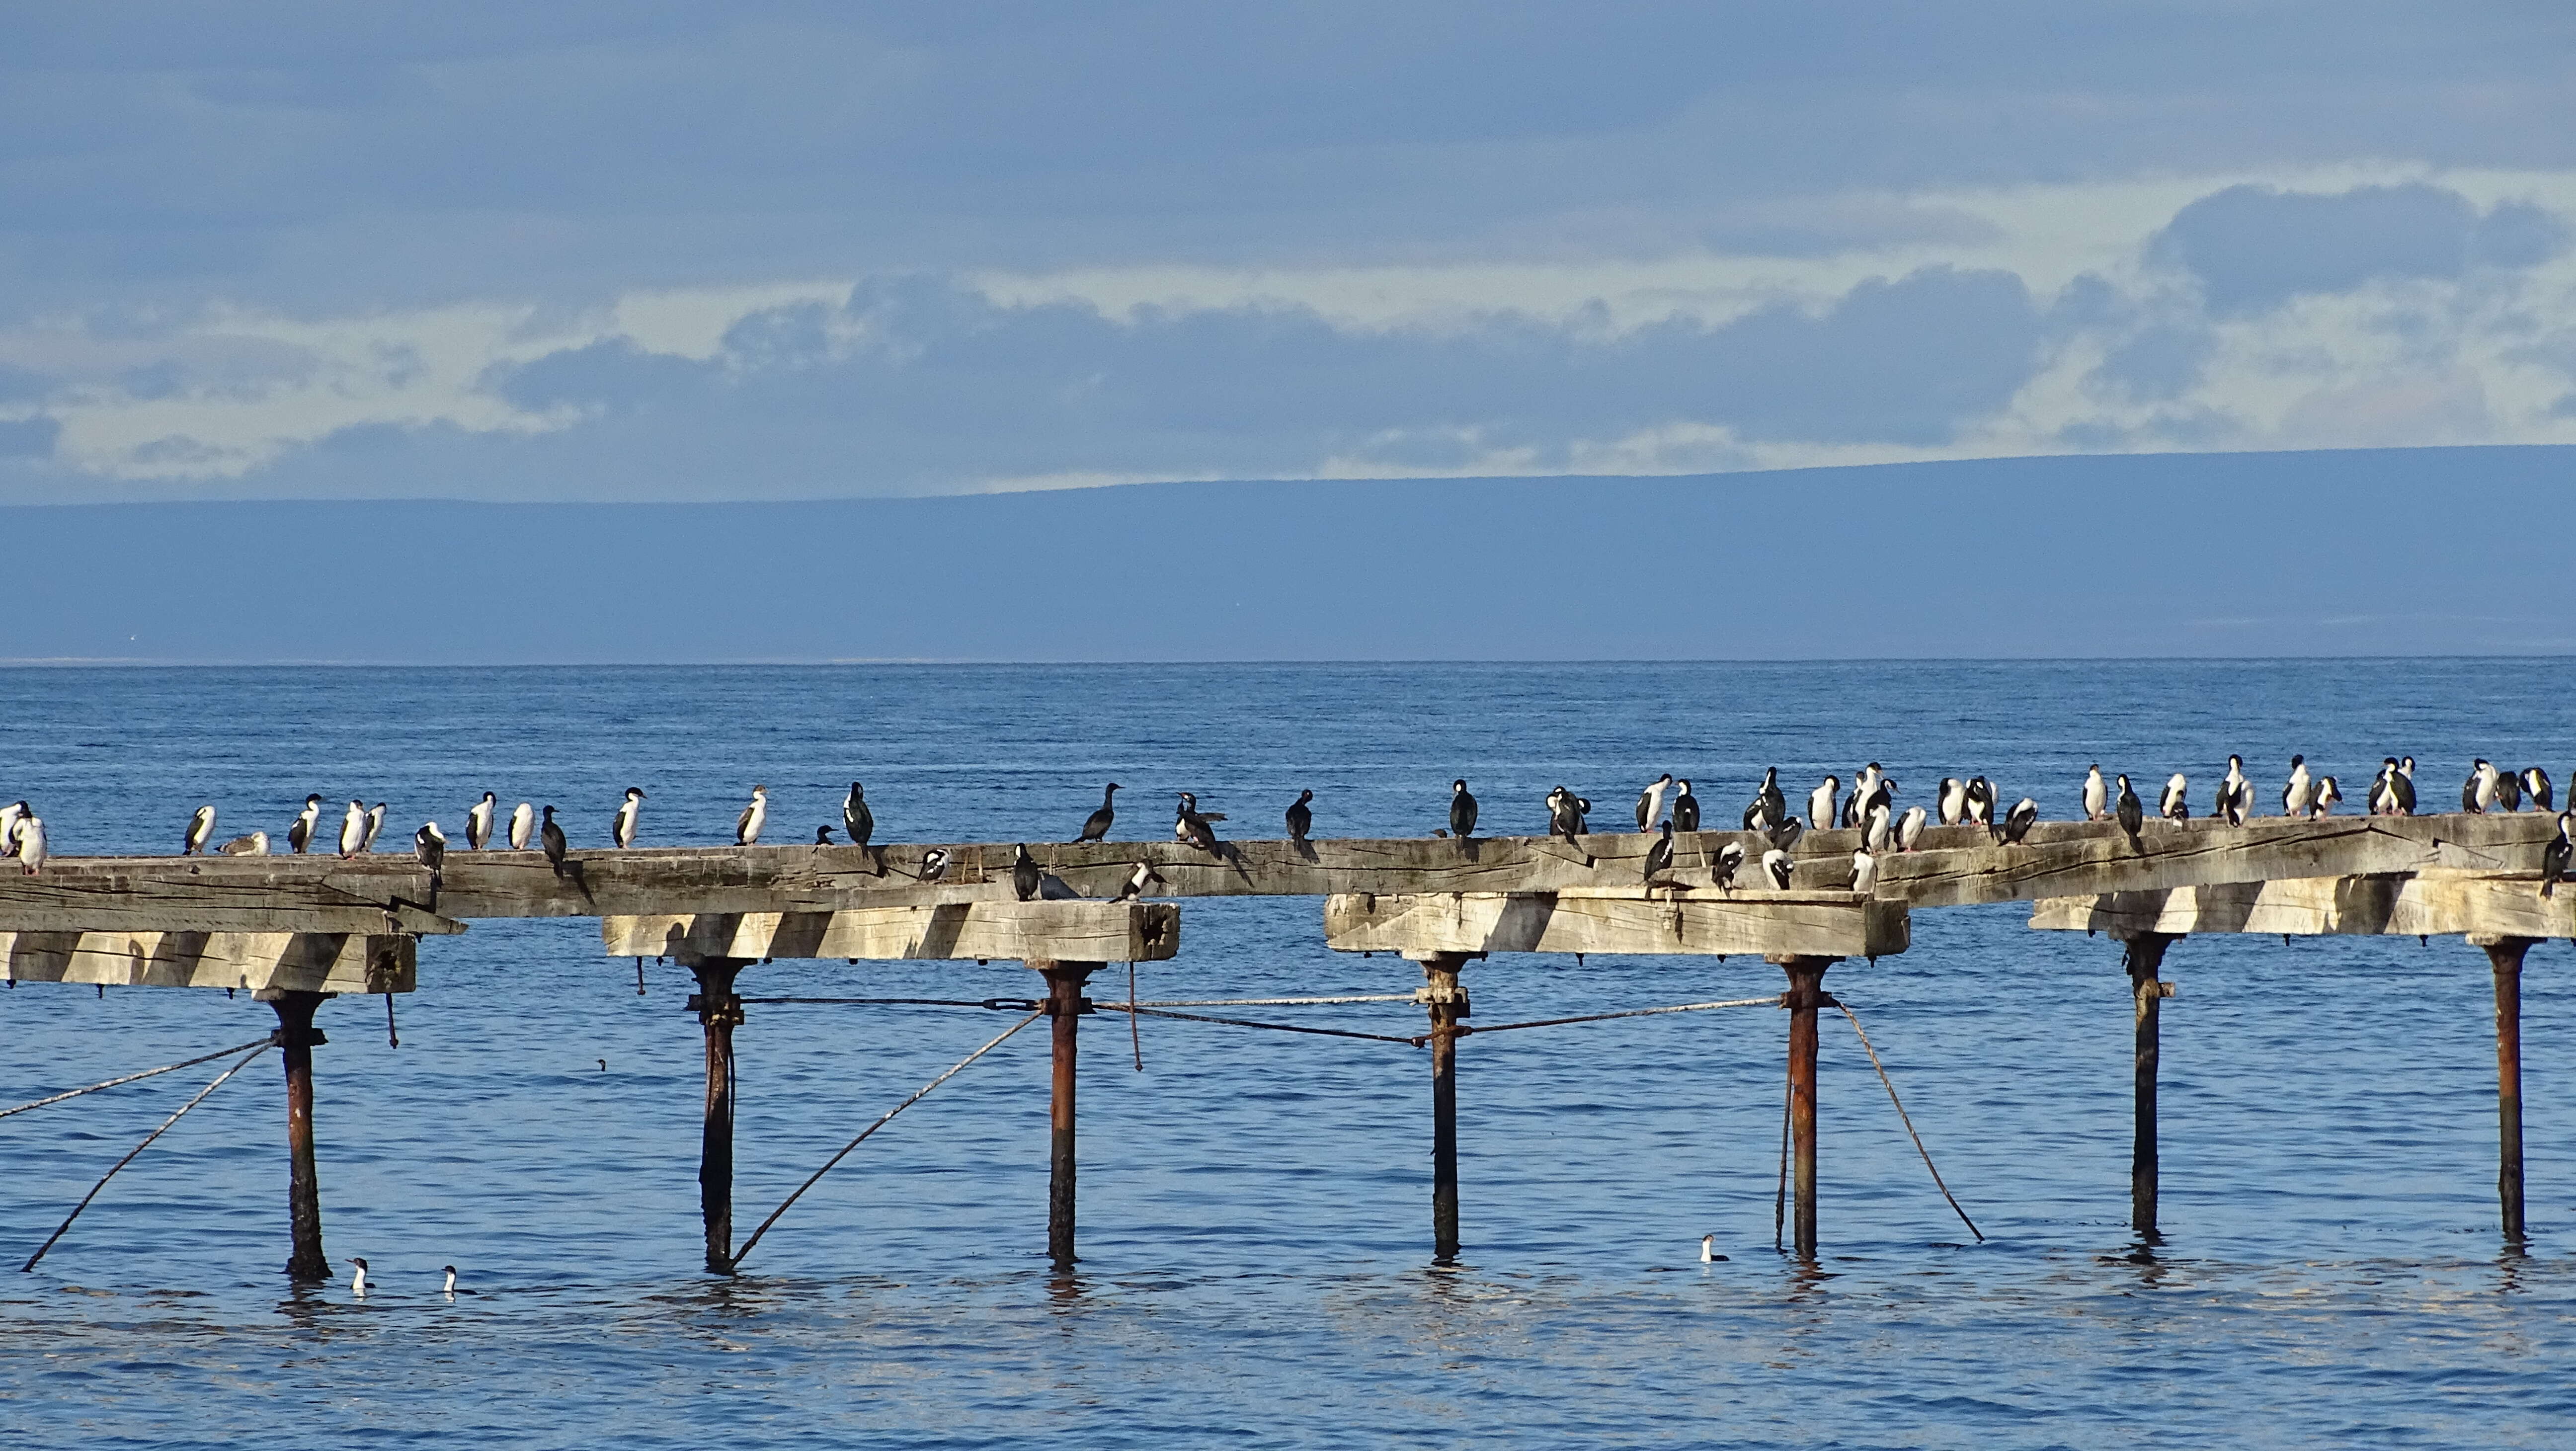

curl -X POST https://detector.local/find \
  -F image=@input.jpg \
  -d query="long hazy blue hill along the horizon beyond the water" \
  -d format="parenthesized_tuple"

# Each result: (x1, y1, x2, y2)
(0, 448, 2576, 665)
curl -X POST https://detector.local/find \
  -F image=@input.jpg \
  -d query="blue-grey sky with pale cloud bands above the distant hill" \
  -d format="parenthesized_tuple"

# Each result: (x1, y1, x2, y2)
(0, 0, 2576, 502)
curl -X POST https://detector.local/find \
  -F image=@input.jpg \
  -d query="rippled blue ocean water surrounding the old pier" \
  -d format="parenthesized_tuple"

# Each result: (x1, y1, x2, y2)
(0, 660, 2576, 1449)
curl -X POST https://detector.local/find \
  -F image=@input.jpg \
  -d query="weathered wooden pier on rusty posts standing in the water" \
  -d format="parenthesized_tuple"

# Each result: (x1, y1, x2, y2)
(0, 812, 2576, 1279)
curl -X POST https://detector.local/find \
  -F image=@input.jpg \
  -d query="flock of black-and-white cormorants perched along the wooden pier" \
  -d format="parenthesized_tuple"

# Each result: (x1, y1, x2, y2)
(0, 755, 2576, 902)
